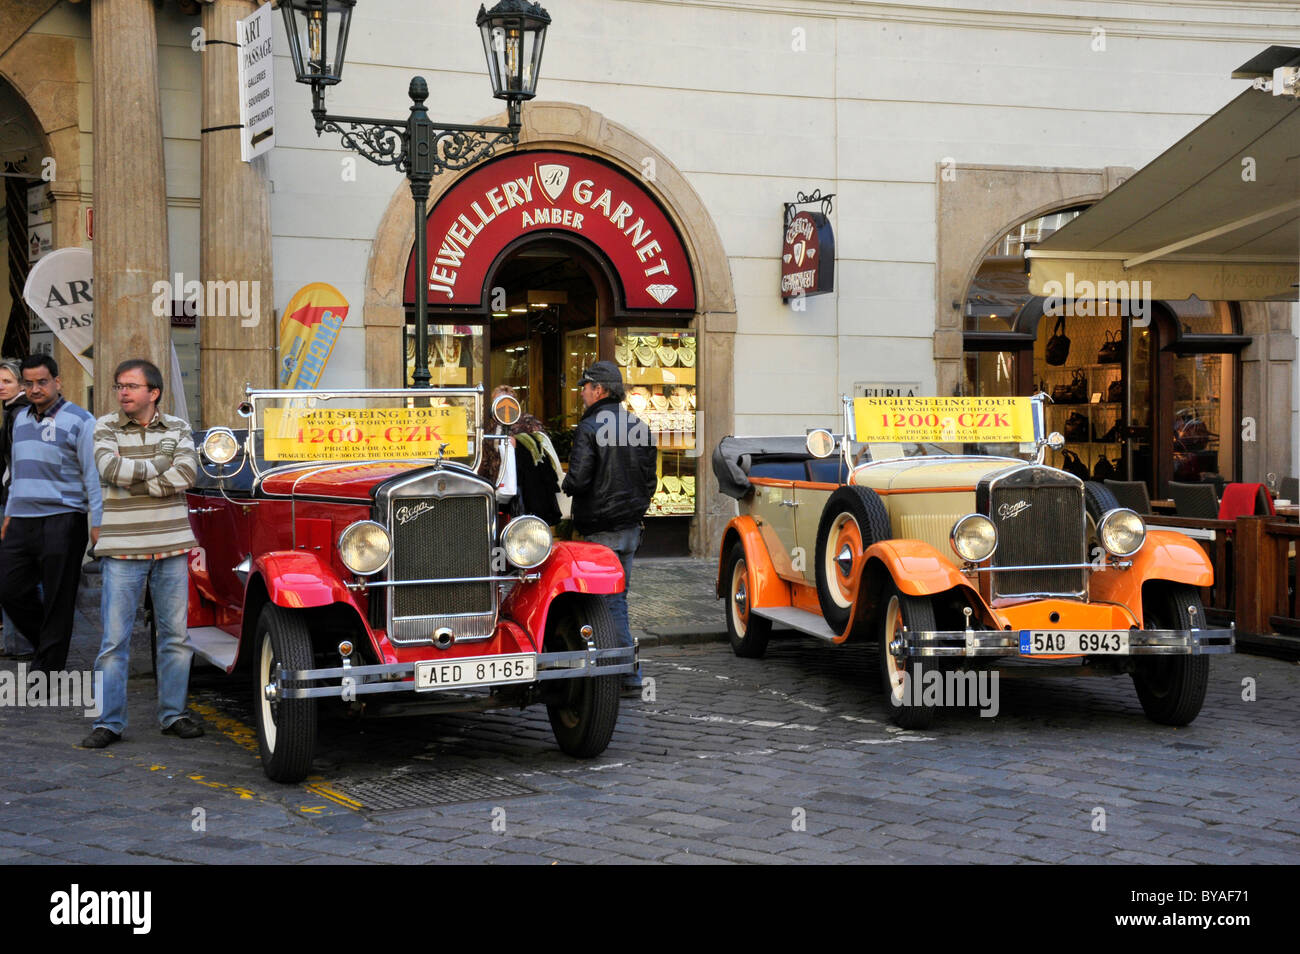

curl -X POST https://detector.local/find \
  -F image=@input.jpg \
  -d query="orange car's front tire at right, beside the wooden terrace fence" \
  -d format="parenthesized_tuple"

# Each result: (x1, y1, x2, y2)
(1134, 586, 1210, 725)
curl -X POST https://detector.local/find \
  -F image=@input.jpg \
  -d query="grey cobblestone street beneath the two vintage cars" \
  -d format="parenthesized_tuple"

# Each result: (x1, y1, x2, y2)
(0, 561, 1300, 863)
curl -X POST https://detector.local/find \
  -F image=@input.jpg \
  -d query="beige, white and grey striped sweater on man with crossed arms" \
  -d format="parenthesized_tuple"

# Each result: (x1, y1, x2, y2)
(95, 411, 199, 558)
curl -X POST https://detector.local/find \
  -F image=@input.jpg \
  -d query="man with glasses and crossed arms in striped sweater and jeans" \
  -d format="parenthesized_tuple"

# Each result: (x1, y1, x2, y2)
(82, 359, 203, 749)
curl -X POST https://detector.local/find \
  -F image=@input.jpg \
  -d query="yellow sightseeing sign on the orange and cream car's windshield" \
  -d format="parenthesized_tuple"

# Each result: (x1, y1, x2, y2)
(853, 398, 1035, 443)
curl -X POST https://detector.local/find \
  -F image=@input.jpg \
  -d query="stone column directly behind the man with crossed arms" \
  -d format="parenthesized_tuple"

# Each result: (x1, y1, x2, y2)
(91, 0, 174, 415)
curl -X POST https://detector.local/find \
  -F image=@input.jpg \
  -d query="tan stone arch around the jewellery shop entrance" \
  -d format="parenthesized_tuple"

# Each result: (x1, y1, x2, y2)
(365, 103, 736, 555)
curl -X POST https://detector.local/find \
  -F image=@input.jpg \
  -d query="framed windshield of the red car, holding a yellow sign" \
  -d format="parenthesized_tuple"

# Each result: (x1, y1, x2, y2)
(248, 387, 482, 473)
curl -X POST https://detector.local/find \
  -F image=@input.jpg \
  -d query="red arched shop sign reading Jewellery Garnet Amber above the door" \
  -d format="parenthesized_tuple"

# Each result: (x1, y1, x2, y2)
(406, 152, 696, 311)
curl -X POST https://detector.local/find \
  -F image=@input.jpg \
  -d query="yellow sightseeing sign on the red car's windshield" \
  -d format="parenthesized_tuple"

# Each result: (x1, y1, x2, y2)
(263, 407, 469, 460)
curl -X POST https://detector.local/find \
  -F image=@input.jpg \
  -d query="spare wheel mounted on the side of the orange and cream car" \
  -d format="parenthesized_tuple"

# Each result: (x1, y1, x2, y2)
(815, 483, 892, 633)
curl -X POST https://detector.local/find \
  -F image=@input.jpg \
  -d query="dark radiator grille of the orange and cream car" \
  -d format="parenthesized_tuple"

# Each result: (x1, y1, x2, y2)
(988, 468, 1088, 597)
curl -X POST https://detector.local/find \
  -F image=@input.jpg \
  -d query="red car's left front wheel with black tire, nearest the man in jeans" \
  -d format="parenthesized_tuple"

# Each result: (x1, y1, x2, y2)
(252, 603, 316, 782)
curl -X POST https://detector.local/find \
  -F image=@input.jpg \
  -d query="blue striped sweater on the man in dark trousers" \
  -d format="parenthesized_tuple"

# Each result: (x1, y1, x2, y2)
(4, 398, 103, 526)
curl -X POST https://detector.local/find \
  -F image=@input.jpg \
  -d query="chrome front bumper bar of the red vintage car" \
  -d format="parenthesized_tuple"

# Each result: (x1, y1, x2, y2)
(271, 643, 640, 702)
